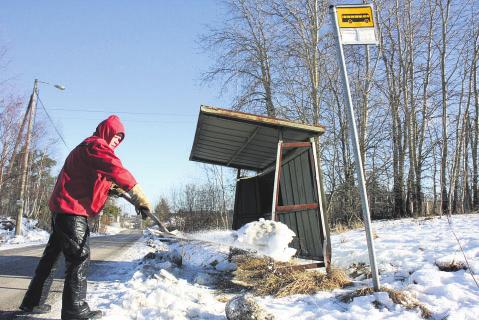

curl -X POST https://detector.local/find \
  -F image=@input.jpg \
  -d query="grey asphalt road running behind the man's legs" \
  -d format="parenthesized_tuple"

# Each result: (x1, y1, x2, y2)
(0, 230, 141, 319)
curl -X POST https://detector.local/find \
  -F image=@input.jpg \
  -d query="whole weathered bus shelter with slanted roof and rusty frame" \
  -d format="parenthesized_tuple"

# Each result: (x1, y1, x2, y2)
(190, 106, 331, 268)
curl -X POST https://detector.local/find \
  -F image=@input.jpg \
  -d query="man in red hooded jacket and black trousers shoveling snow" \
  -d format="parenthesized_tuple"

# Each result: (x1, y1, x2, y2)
(20, 116, 152, 320)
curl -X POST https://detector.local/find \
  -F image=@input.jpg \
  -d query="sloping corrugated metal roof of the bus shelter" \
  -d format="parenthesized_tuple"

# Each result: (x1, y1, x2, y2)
(190, 106, 324, 171)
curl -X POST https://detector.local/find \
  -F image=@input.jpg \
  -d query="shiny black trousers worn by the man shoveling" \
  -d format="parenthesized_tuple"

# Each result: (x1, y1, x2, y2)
(22, 213, 90, 319)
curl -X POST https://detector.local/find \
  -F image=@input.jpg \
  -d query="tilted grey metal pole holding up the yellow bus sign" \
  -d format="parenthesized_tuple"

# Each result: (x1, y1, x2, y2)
(329, 6, 380, 291)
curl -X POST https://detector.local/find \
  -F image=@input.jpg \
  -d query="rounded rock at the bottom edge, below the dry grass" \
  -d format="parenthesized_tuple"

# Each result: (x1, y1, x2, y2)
(226, 294, 274, 320)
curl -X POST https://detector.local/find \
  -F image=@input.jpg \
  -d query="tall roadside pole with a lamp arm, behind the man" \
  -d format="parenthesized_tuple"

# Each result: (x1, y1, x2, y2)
(15, 79, 65, 236)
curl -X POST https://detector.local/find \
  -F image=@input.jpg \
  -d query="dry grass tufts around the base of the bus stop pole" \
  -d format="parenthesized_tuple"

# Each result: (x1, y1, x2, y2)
(339, 288, 432, 319)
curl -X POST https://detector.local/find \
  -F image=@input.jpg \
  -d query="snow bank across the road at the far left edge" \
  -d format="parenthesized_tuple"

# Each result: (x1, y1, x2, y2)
(0, 217, 50, 250)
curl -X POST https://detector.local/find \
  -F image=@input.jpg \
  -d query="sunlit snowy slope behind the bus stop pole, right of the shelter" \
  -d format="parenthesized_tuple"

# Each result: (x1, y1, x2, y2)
(332, 214, 479, 320)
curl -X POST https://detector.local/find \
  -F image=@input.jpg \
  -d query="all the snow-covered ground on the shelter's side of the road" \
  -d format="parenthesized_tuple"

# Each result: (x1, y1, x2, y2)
(79, 214, 479, 320)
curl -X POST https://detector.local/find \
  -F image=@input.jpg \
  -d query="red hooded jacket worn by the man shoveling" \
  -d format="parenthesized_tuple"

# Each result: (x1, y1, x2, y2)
(49, 116, 136, 217)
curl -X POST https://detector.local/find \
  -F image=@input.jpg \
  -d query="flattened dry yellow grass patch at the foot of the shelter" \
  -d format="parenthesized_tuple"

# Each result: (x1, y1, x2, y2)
(232, 255, 351, 297)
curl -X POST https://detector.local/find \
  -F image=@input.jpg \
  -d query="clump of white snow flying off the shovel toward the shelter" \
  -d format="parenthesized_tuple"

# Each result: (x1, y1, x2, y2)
(188, 219, 296, 261)
